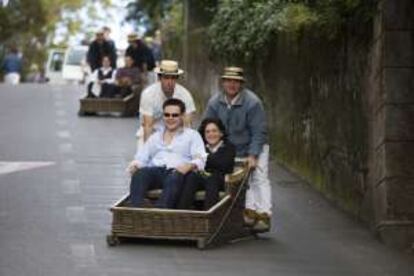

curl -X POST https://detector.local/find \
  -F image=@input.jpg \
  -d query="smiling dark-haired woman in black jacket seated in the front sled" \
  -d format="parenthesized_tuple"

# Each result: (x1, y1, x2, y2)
(177, 118, 236, 210)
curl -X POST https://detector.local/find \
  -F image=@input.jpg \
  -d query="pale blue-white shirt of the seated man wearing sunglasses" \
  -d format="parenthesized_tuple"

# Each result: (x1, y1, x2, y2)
(135, 128, 207, 170)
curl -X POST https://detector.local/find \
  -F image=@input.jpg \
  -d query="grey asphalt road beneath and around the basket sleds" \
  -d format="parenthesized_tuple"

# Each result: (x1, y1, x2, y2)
(0, 84, 414, 276)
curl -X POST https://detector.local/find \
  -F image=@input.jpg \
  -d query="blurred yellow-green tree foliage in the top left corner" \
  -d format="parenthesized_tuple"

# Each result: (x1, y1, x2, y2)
(0, 0, 110, 77)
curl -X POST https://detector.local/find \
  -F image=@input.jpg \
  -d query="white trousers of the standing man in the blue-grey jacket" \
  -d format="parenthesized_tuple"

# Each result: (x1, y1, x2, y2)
(246, 145, 272, 215)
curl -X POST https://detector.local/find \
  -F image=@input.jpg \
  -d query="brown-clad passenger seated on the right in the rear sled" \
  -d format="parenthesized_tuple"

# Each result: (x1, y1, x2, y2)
(115, 56, 141, 98)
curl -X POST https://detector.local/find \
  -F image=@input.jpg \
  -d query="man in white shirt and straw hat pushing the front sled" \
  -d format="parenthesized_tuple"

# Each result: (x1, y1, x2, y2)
(136, 60, 196, 149)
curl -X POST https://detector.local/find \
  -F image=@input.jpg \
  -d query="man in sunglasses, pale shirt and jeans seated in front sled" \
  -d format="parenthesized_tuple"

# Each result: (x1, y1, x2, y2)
(127, 99, 207, 208)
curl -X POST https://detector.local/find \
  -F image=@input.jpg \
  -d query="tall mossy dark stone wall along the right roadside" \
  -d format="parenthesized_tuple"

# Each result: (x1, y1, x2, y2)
(171, 0, 414, 248)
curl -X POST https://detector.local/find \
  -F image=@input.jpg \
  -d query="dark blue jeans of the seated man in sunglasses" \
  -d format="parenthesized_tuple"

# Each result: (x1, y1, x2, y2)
(129, 167, 184, 208)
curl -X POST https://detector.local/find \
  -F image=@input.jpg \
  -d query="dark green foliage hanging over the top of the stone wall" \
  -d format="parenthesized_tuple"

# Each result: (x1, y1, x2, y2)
(208, 0, 374, 62)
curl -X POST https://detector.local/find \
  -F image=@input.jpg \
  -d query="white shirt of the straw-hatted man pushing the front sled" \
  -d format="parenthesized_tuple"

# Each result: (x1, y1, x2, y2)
(139, 81, 196, 131)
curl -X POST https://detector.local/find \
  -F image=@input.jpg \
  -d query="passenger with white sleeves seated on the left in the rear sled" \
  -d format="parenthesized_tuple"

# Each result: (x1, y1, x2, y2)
(86, 56, 116, 98)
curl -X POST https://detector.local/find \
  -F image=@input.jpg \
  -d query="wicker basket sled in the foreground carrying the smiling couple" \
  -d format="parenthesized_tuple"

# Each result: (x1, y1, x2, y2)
(107, 165, 251, 248)
